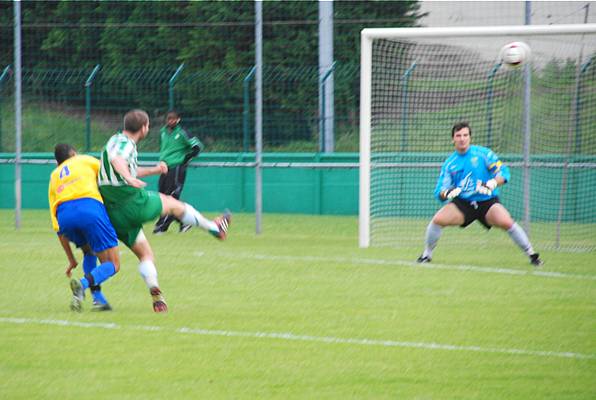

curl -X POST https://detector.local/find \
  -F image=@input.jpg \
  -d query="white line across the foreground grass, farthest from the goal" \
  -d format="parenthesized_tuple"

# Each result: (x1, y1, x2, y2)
(0, 317, 596, 360)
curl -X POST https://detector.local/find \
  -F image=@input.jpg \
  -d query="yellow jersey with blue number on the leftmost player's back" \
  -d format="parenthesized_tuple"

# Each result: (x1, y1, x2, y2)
(48, 155, 103, 231)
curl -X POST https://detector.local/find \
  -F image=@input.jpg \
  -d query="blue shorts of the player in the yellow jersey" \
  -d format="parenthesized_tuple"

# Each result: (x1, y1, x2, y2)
(56, 198, 118, 253)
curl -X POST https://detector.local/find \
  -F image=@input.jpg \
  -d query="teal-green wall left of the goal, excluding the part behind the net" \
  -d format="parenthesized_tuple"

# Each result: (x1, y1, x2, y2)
(0, 153, 358, 215)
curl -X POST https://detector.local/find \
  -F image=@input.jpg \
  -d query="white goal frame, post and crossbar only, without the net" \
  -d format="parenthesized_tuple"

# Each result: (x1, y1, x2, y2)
(359, 24, 596, 247)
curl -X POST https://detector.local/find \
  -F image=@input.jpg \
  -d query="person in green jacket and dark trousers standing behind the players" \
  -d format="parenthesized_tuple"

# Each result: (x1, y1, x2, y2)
(153, 110, 203, 234)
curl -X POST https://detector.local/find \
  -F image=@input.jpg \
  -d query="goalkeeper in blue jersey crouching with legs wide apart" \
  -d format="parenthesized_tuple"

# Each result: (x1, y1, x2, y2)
(417, 122, 542, 266)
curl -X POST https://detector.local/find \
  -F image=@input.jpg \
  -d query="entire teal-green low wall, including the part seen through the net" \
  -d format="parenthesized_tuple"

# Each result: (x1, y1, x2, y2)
(0, 153, 596, 222)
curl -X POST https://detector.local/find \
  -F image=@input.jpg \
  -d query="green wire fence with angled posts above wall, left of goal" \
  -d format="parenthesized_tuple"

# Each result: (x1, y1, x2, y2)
(0, 64, 359, 152)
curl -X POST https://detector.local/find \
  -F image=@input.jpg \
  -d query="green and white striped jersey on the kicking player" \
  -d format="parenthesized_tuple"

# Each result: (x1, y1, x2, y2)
(97, 132, 137, 186)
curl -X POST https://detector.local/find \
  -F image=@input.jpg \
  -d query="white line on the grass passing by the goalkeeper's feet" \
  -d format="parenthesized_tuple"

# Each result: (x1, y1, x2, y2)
(207, 252, 596, 281)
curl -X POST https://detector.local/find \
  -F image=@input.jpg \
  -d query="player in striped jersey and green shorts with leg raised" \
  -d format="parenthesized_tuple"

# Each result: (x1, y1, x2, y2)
(98, 110, 231, 312)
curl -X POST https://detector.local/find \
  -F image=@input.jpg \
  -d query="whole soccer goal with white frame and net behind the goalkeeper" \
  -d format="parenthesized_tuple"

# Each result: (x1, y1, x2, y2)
(359, 24, 596, 251)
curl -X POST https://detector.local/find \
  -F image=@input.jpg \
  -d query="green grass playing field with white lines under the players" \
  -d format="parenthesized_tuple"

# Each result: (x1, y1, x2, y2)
(0, 210, 596, 399)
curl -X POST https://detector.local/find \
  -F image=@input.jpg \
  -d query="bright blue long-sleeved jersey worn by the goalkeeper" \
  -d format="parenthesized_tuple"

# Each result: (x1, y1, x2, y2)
(435, 145, 511, 202)
